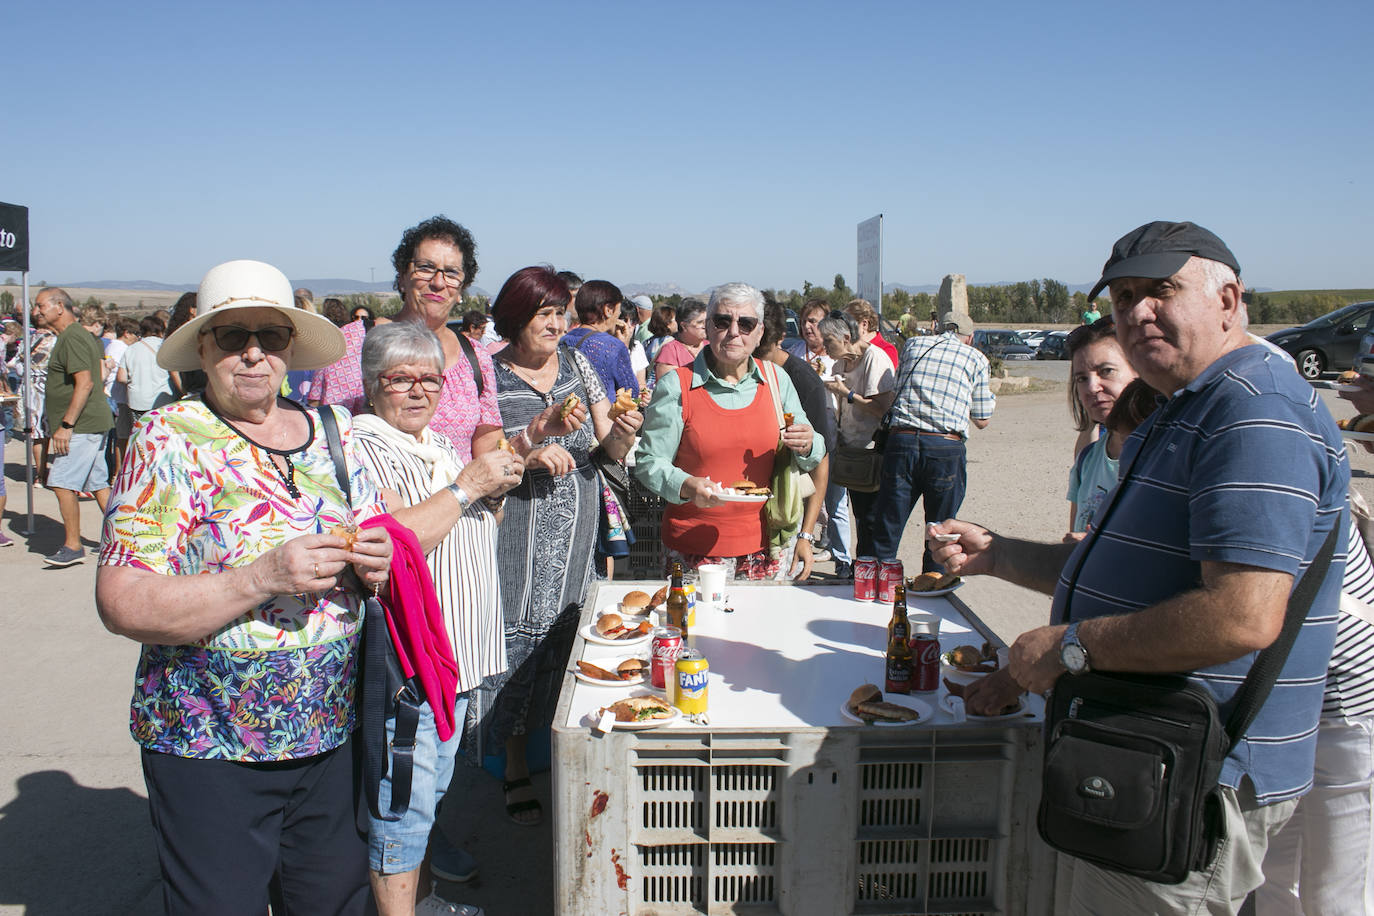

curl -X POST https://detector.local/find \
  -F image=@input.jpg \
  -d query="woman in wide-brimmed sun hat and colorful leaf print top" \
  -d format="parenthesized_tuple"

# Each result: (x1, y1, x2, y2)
(96, 261, 392, 913)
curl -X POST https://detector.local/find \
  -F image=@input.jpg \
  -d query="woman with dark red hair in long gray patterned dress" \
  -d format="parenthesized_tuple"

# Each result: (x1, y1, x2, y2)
(478, 266, 643, 825)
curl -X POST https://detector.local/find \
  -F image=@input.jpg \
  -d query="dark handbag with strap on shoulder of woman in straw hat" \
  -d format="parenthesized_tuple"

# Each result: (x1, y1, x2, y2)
(320, 405, 425, 821)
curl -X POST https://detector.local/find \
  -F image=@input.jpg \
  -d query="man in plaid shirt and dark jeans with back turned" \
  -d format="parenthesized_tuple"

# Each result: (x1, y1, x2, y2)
(871, 312, 996, 571)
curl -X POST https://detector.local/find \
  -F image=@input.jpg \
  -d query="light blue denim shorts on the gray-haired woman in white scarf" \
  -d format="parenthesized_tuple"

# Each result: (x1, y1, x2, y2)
(367, 694, 467, 875)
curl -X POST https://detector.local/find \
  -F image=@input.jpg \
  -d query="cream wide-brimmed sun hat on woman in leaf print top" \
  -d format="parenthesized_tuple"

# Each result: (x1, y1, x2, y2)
(158, 261, 344, 372)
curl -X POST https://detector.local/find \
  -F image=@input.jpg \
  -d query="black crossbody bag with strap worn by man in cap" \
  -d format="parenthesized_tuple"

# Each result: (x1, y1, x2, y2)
(1036, 427, 1341, 884)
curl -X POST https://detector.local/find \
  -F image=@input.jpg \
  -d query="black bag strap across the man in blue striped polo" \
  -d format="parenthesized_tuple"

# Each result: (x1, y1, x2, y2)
(1059, 405, 1341, 754)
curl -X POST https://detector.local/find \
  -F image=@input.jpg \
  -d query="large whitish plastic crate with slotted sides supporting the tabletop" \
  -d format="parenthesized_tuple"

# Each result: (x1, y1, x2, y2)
(554, 586, 1054, 916)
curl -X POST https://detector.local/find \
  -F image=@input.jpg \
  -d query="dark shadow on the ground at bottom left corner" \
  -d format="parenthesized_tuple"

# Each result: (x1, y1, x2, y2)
(0, 770, 159, 916)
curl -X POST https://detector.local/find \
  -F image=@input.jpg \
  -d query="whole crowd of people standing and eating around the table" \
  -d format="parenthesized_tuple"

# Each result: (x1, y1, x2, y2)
(0, 217, 1374, 915)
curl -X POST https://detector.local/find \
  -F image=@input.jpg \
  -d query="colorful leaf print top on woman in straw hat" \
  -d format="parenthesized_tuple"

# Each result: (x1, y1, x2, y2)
(100, 400, 385, 762)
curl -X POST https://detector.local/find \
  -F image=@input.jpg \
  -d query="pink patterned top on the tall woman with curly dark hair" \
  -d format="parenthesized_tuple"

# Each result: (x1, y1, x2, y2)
(311, 321, 502, 463)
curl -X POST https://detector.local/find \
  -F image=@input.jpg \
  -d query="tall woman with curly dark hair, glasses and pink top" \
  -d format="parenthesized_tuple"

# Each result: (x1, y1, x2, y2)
(311, 216, 502, 461)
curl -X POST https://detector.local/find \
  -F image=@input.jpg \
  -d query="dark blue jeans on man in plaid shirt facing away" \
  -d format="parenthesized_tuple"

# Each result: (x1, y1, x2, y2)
(872, 430, 969, 571)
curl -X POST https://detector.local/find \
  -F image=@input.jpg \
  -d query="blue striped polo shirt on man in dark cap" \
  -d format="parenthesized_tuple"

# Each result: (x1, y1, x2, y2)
(1051, 346, 1349, 803)
